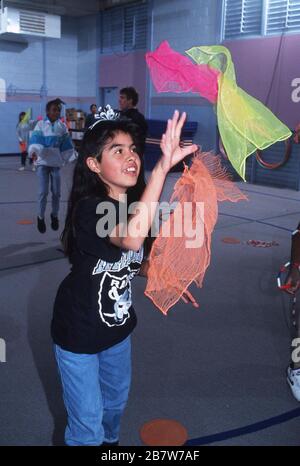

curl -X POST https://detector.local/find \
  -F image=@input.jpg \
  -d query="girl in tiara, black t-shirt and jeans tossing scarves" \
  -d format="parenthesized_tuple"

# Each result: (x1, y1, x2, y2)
(51, 109, 197, 445)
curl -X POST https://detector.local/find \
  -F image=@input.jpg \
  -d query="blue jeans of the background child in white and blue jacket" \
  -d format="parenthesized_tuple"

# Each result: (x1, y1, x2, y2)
(37, 165, 60, 218)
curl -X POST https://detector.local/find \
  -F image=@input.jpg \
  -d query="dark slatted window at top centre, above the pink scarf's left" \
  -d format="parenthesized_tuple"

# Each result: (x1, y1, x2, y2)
(101, 2, 148, 53)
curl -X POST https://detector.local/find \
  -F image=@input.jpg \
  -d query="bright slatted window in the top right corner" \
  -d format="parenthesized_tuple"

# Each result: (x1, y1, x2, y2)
(223, 0, 300, 39)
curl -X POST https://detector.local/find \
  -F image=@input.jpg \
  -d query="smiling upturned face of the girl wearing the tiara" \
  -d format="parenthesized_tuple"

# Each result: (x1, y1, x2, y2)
(87, 132, 141, 199)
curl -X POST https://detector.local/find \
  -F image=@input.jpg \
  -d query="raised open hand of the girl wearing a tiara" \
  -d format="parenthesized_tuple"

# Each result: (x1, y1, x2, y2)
(159, 110, 198, 174)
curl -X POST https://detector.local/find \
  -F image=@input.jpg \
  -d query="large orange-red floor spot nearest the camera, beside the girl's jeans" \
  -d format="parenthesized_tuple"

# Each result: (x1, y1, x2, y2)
(140, 419, 188, 446)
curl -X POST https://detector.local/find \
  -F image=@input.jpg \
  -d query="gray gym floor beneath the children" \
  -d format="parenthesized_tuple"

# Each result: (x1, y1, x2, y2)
(0, 158, 300, 446)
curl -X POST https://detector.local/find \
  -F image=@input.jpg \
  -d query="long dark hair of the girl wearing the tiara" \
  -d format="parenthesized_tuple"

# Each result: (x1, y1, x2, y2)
(61, 119, 150, 258)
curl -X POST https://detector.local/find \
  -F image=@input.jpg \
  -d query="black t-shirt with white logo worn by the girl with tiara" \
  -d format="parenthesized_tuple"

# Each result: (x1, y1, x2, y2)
(51, 198, 143, 354)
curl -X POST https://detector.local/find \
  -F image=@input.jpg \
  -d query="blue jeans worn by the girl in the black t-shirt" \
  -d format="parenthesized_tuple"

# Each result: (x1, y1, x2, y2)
(54, 337, 131, 446)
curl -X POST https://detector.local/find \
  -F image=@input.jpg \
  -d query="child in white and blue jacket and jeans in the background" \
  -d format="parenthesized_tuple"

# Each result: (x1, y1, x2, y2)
(28, 99, 77, 233)
